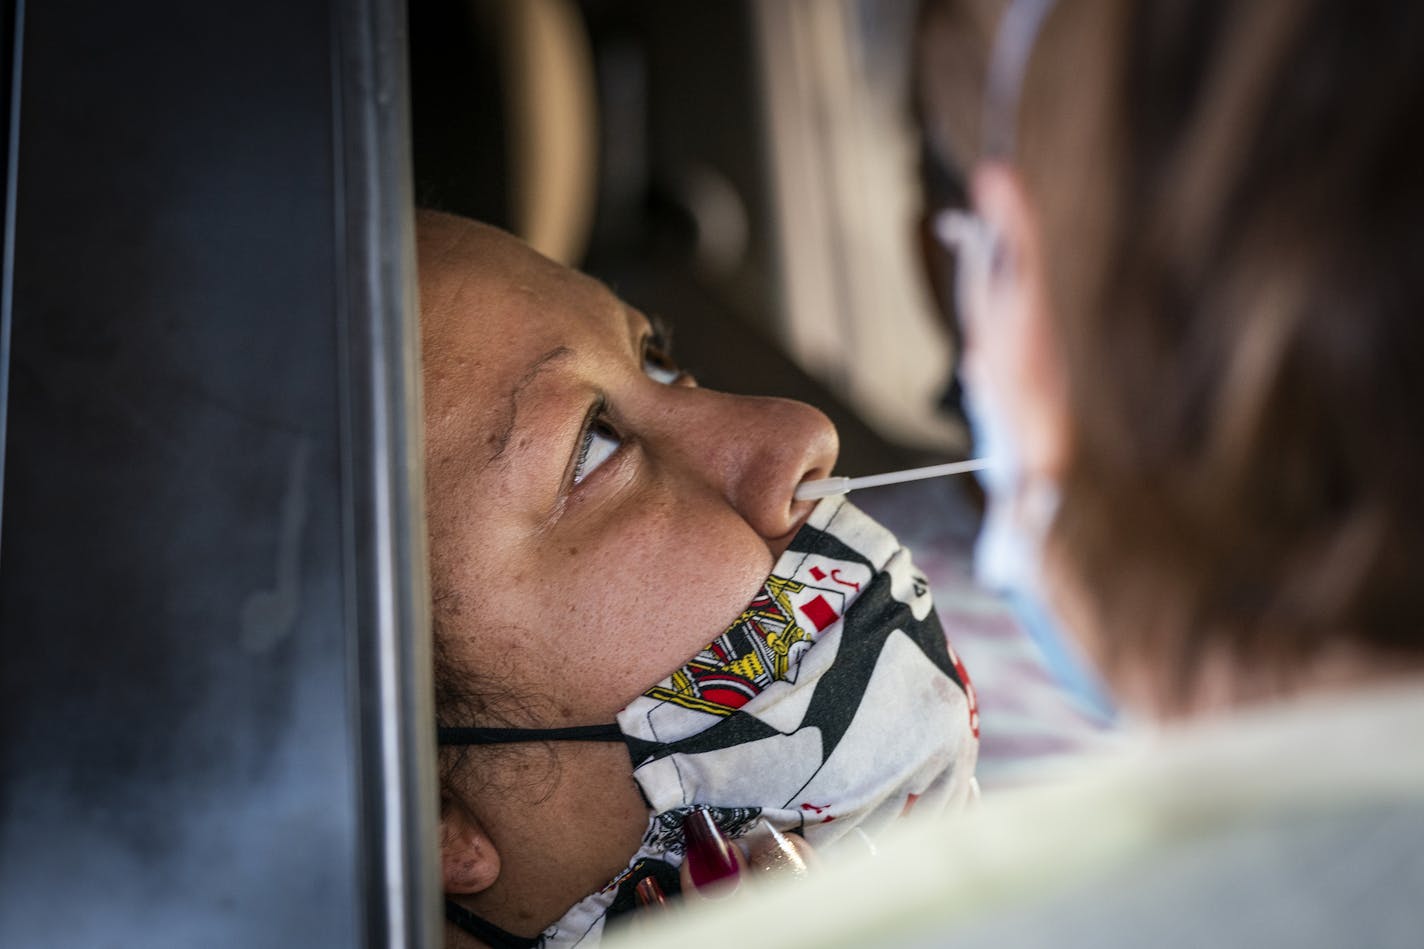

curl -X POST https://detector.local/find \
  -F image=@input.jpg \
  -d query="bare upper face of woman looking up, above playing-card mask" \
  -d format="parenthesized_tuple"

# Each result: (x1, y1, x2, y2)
(419, 215, 837, 727)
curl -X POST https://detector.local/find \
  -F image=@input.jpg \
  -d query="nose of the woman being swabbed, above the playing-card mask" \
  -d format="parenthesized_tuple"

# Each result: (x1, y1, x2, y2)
(672, 389, 840, 544)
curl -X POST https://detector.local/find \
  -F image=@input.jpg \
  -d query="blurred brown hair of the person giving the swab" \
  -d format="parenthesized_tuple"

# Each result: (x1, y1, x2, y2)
(1015, 0, 1424, 698)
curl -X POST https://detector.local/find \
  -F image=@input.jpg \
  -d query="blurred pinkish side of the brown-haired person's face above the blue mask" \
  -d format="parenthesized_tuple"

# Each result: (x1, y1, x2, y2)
(971, 164, 1068, 480)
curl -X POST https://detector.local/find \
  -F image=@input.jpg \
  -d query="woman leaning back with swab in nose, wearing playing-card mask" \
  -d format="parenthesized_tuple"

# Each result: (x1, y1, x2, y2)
(416, 212, 977, 946)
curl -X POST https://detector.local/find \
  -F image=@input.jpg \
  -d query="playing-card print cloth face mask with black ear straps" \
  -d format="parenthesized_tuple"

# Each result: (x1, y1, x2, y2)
(440, 497, 978, 946)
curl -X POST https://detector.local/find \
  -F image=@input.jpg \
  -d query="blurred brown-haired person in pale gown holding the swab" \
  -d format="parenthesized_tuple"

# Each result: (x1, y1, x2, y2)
(618, 0, 1424, 949)
